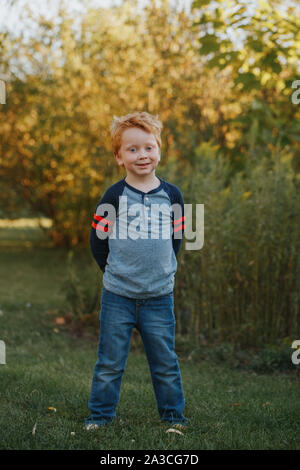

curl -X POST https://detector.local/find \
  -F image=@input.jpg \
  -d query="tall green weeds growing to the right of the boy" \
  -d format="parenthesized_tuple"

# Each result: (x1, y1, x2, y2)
(176, 144, 300, 347)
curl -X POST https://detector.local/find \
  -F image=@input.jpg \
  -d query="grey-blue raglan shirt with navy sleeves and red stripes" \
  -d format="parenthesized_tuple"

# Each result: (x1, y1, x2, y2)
(90, 177, 185, 299)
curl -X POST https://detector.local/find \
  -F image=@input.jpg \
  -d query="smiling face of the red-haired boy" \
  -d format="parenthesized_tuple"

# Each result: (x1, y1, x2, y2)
(115, 127, 160, 180)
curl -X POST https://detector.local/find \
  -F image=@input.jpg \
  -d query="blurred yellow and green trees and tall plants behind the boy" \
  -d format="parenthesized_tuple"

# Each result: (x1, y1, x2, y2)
(0, 0, 300, 350)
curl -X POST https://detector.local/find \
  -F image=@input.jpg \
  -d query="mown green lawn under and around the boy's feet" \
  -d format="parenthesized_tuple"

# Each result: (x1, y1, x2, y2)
(0, 229, 300, 450)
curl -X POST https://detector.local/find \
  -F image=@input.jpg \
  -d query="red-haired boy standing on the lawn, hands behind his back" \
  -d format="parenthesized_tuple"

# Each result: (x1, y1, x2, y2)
(85, 112, 188, 430)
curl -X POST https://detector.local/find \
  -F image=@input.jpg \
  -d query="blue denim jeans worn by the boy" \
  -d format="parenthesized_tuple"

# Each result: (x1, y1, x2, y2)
(85, 287, 188, 425)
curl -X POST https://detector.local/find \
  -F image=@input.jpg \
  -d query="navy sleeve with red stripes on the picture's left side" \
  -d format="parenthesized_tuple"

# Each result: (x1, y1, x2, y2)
(90, 186, 117, 273)
